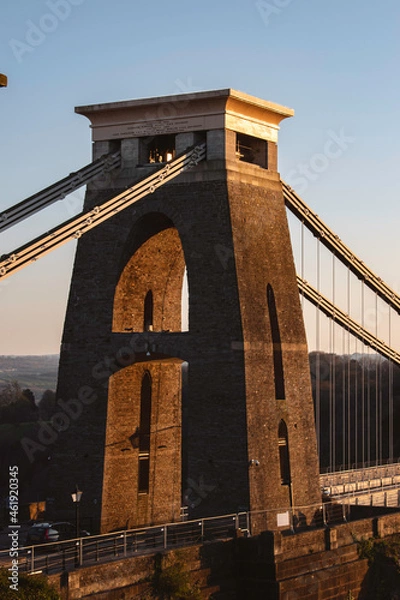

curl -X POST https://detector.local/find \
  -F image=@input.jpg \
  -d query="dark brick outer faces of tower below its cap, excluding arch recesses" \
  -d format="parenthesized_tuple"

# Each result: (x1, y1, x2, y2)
(49, 152, 319, 530)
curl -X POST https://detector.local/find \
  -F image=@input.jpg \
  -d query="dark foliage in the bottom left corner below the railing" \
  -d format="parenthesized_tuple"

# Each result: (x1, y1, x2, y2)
(0, 568, 60, 600)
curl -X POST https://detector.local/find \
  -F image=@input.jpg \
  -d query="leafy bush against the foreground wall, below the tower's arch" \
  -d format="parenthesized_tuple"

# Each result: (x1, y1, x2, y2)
(152, 557, 201, 600)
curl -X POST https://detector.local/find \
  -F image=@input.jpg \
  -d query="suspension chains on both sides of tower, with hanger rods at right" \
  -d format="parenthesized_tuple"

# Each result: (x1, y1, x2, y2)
(0, 139, 400, 497)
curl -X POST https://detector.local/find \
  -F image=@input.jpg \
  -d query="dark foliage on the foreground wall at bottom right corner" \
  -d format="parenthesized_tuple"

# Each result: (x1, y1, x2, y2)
(358, 535, 400, 600)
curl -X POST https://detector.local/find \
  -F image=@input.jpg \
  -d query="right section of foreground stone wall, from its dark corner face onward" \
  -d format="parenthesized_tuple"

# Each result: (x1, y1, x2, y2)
(235, 512, 400, 600)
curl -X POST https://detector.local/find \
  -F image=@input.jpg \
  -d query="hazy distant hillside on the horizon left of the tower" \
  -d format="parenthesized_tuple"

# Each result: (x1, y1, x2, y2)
(0, 354, 59, 402)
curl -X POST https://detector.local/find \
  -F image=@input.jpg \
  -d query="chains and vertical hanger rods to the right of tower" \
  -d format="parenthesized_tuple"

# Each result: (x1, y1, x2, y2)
(284, 184, 400, 477)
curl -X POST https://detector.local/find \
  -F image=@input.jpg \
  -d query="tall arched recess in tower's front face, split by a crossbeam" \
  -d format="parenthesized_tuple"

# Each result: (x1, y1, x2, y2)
(102, 213, 186, 530)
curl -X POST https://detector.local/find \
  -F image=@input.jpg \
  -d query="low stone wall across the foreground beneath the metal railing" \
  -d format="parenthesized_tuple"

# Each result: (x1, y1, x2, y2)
(50, 513, 400, 600)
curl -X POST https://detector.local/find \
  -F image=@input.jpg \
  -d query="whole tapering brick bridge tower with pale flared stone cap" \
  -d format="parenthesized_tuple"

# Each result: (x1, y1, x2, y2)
(52, 89, 321, 531)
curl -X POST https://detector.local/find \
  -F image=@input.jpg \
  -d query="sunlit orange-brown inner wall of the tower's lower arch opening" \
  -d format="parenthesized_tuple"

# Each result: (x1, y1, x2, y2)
(102, 360, 181, 531)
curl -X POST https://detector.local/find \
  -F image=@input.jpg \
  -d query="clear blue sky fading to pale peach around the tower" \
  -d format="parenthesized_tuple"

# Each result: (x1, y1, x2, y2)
(0, 0, 400, 354)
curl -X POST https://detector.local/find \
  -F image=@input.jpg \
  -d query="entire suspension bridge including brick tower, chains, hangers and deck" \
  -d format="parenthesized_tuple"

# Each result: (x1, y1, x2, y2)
(0, 89, 400, 598)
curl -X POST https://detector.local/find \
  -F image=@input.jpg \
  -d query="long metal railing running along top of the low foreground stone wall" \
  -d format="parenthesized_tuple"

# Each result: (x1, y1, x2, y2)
(0, 502, 366, 574)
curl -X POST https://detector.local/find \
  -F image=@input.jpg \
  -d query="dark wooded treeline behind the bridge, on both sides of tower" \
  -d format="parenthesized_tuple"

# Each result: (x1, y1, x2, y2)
(0, 352, 400, 495)
